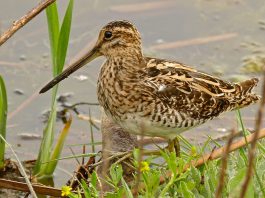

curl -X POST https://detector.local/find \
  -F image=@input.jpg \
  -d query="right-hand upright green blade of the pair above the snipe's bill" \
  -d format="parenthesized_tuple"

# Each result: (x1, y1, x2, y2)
(56, 0, 74, 75)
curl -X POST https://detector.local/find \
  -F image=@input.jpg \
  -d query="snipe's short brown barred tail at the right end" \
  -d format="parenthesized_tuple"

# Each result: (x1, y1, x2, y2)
(233, 78, 260, 109)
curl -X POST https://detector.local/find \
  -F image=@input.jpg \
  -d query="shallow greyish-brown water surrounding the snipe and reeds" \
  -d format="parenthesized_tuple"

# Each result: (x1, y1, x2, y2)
(0, 0, 265, 185)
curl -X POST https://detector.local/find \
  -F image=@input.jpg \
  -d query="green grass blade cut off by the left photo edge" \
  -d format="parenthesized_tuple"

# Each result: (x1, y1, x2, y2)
(0, 75, 7, 169)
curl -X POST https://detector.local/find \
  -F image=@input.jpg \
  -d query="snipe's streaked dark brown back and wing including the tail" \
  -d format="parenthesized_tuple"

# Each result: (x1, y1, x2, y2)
(143, 57, 260, 113)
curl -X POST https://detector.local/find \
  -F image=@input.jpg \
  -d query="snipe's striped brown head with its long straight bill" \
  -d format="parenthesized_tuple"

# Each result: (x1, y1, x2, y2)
(40, 21, 142, 93)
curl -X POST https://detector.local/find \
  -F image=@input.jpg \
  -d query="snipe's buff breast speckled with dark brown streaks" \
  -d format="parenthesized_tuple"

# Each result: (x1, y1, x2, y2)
(97, 62, 141, 120)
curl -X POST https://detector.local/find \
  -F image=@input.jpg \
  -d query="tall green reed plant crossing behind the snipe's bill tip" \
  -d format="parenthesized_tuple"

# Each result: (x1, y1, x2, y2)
(34, 0, 74, 178)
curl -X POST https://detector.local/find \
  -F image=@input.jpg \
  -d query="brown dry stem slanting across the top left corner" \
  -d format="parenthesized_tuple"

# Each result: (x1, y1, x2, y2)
(0, 0, 56, 46)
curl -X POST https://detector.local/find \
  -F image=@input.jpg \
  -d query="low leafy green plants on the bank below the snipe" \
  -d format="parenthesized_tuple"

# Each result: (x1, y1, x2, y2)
(68, 112, 265, 198)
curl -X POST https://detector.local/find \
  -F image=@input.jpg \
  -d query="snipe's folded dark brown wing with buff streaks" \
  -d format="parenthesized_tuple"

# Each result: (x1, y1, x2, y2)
(142, 58, 236, 119)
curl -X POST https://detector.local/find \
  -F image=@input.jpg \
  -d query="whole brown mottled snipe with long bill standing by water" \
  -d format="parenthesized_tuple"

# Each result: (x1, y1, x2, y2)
(40, 21, 259, 153)
